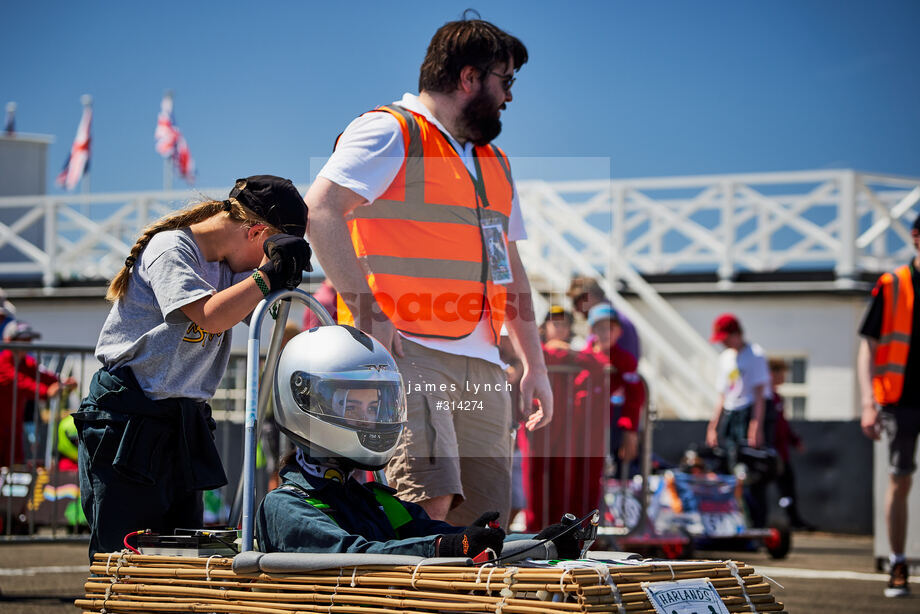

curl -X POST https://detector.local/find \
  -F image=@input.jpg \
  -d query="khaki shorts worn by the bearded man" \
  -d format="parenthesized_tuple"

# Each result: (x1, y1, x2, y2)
(386, 339, 513, 526)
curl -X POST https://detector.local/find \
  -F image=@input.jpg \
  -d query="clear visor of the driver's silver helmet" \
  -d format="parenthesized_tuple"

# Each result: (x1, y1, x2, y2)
(291, 369, 406, 430)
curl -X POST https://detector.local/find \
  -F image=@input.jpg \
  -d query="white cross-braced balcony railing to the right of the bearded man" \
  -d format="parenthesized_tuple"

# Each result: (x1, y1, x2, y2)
(519, 170, 920, 285)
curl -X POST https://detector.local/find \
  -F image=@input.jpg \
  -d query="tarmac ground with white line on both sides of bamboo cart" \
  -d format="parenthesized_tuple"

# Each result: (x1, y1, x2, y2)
(0, 533, 920, 614)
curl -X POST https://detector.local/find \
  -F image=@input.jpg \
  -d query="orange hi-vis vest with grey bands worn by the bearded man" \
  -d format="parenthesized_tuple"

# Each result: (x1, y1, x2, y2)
(338, 105, 513, 344)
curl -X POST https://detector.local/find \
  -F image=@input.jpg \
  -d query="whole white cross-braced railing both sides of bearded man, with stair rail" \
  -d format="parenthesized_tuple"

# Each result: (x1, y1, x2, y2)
(0, 170, 920, 417)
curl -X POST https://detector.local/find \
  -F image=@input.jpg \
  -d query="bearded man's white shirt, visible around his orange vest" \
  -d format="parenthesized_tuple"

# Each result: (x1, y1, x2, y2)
(319, 93, 527, 365)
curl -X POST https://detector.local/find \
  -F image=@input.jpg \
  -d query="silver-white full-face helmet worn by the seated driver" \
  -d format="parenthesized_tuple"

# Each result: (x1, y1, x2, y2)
(275, 326, 406, 470)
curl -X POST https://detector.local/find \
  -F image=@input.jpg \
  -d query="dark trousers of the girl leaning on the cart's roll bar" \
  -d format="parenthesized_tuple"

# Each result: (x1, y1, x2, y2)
(78, 421, 203, 562)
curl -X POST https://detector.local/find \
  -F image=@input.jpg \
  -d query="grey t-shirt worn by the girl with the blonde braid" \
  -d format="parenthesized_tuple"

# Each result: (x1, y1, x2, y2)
(96, 229, 250, 401)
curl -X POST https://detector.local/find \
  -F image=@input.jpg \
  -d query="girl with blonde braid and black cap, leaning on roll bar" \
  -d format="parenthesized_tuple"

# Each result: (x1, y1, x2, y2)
(74, 175, 312, 561)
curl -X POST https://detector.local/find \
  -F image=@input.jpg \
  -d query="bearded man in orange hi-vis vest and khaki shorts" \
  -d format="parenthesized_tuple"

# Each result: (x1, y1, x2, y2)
(305, 19, 553, 526)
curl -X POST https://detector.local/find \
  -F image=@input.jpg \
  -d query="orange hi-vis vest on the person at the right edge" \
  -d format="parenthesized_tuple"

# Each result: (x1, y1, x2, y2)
(872, 265, 914, 405)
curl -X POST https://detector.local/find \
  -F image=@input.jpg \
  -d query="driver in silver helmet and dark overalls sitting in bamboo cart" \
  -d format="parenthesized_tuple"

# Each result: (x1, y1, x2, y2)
(256, 326, 579, 558)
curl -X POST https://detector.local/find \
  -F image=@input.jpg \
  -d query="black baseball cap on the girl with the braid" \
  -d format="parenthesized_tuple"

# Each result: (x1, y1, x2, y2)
(230, 175, 307, 237)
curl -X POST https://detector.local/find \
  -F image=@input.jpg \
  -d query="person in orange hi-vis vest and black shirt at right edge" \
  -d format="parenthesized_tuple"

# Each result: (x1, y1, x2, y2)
(856, 216, 920, 597)
